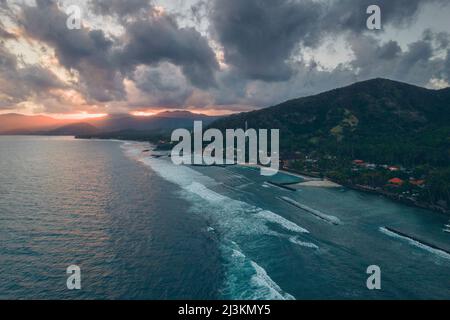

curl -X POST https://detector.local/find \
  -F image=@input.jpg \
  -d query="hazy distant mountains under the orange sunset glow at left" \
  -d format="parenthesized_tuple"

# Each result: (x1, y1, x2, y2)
(0, 111, 219, 136)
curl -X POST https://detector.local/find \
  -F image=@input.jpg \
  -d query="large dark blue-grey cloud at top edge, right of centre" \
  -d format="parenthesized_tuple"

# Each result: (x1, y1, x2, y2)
(210, 0, 321, 81)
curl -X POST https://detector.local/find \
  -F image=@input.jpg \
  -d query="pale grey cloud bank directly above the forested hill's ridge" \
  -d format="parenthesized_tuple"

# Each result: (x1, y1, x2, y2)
(215, 25, 450, 107)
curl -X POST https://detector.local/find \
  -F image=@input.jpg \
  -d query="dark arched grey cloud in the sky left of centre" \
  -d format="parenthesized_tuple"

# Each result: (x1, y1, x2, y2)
(118, 16, 219, 88)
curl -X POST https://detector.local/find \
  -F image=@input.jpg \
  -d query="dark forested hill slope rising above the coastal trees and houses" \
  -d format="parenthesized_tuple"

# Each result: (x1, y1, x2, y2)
(212, 79, 450, 166)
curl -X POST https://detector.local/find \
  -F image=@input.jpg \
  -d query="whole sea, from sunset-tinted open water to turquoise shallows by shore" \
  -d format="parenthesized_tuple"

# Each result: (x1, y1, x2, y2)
(0, 137, 450, 299)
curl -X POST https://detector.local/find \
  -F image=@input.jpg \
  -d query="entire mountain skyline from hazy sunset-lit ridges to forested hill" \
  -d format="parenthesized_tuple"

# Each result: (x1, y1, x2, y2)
(4, 79, 450, 166)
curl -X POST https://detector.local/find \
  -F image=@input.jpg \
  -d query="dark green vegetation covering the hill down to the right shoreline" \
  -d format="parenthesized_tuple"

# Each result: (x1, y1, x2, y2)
(212, 79, 450, 210)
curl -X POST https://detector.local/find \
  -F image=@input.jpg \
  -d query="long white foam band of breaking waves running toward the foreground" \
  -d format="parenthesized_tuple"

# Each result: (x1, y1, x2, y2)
(124, 144, 313, 300)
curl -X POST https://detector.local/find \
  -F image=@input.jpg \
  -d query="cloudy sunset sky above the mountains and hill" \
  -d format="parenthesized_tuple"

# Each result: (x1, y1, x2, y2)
(0, 0, 450, 117)
